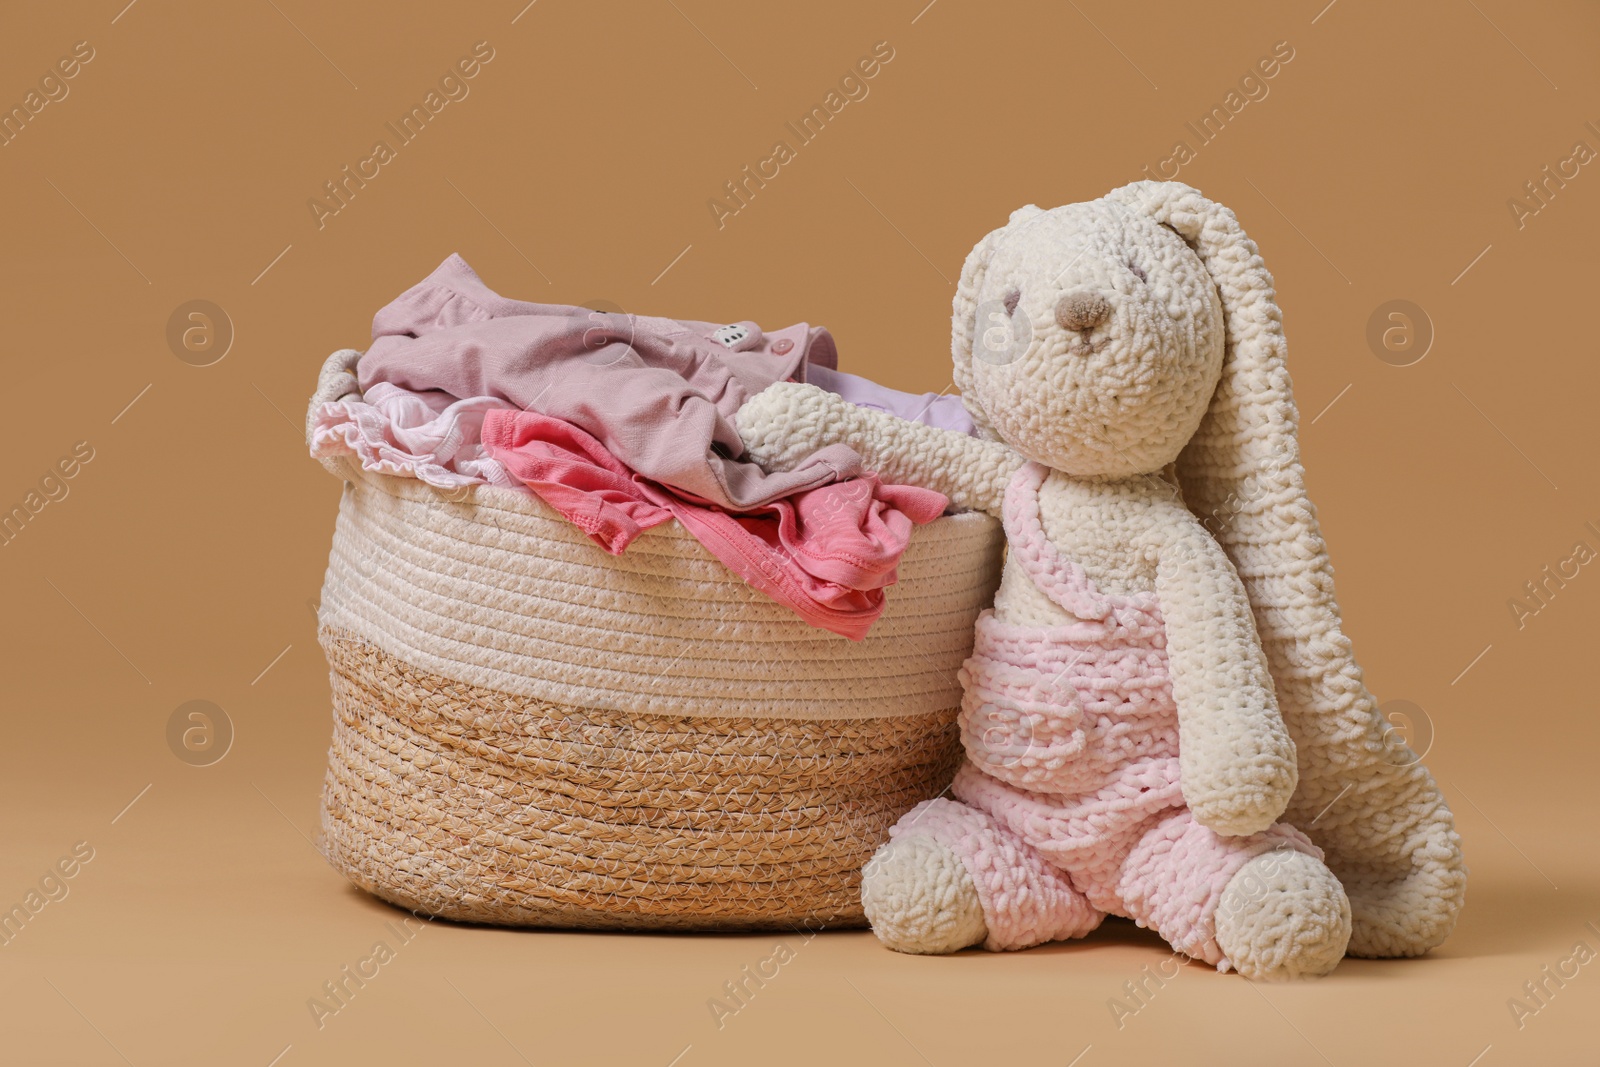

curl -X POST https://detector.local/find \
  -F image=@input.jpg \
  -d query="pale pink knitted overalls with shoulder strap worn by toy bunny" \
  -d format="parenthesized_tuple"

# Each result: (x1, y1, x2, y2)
(890, 464, 1322, 965)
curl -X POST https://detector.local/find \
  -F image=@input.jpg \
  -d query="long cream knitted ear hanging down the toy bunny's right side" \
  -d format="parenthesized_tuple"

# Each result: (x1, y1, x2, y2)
(1107, 182, 1466, 957)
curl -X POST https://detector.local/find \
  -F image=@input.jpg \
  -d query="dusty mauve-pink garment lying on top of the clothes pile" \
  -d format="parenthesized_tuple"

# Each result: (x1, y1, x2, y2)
(357, 254, 861, 510)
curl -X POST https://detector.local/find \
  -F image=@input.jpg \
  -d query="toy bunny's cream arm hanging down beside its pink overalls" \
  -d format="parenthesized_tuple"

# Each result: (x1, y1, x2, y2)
(1155, 504, 1299, 835)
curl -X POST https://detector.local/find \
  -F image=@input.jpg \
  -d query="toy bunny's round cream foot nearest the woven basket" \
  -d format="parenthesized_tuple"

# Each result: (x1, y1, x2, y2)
(861, 833, 989, 955)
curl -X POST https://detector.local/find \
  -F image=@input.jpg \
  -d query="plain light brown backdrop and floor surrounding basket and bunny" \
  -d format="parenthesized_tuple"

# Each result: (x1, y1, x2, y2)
(0, 0, 1600, 1067)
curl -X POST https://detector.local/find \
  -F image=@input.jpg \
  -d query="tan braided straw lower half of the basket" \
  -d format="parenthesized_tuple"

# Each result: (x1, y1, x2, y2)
(320, 627, 960, 929)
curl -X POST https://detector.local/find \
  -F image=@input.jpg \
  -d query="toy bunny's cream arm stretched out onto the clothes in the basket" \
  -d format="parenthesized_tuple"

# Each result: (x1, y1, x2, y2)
(734, 382, 1026, 517)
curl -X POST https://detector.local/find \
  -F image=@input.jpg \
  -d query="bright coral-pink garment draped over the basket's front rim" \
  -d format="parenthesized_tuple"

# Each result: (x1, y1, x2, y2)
(483, 410, 949, 640)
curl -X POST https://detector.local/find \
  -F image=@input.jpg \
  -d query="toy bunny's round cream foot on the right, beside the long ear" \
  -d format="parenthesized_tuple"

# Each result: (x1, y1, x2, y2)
(1216, 851, 1350, 981)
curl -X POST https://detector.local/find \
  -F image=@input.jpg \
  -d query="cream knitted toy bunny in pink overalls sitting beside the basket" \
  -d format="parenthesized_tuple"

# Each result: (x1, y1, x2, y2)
(738, 182, 1466, 979)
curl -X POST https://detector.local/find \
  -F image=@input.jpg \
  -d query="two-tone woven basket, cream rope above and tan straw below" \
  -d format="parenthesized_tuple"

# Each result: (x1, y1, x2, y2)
(307, 350, 1002, 929)
